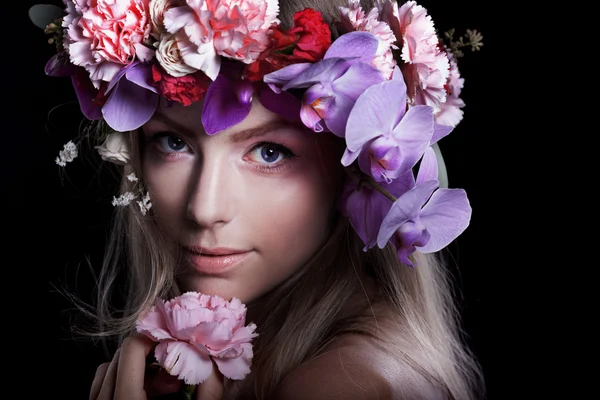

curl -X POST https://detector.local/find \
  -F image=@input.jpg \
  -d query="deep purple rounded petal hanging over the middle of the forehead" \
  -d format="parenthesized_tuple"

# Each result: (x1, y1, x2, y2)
(202, 74, 252, 136)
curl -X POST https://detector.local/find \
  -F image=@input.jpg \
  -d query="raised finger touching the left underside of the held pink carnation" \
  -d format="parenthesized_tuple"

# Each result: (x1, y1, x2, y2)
(114, 335, 154, 400)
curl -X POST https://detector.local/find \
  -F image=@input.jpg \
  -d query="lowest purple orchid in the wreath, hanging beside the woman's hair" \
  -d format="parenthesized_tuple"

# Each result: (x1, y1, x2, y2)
(377, 147, 471, 266)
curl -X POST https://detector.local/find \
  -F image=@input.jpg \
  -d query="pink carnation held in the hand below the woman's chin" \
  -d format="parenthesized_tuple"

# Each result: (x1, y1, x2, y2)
(136, 292, 257, 385)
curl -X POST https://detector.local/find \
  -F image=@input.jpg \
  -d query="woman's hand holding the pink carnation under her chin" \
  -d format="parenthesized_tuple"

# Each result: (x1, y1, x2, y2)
(90, 335, 223, 400)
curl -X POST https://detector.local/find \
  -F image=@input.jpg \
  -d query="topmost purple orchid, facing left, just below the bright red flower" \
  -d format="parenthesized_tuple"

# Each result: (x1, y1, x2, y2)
(263, 32, 385, 137)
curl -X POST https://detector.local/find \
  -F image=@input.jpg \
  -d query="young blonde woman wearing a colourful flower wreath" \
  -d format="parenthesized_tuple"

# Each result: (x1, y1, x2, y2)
(32, 0, 483, 400)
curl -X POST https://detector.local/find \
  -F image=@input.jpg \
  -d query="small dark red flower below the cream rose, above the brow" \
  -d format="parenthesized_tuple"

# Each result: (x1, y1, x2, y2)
(152, 64, 211, 106)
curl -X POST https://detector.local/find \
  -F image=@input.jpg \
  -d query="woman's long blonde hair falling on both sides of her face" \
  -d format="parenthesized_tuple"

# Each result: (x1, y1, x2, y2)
(74, 0, 484, 400)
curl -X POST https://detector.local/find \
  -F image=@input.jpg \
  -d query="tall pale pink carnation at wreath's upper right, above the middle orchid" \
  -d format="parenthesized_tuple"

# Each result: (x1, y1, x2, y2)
(378, 0, 450, 112)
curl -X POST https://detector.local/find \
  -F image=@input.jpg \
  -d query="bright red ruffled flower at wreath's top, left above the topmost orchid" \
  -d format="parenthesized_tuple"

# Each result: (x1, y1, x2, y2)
(290, 8, 331, 62)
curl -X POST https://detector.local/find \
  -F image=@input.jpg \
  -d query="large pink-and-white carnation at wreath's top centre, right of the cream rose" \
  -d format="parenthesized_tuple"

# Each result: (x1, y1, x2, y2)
(164, 0, 279, 80)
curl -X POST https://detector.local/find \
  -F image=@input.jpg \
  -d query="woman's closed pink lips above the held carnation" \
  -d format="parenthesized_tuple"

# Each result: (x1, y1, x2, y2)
(184, 247, 251, 274)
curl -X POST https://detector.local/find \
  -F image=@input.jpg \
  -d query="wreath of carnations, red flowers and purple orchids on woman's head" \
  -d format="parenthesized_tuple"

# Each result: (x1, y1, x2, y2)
(29, 0, 483, 265)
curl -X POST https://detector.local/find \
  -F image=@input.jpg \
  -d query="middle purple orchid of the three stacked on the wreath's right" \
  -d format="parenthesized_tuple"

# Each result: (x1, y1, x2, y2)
(342, 67, 434, 183)
